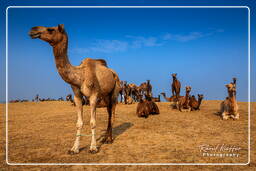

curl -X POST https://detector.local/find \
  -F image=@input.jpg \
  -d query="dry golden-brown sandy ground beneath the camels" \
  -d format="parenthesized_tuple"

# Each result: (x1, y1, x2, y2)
(0, 101, 256, 170)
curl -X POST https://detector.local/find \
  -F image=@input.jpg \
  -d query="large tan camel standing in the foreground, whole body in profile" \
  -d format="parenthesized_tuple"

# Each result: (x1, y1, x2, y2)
(29, 24, 120, 154)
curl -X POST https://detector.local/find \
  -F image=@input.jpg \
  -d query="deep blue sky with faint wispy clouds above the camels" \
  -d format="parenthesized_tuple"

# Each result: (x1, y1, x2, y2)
(0, 0, 253, 101)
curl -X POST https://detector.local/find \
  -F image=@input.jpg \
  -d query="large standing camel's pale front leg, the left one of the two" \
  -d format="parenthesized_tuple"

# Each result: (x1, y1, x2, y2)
(68, 93, 83, 154)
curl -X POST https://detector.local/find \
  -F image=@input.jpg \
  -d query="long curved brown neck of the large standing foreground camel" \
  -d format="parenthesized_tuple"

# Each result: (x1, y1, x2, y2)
(53, 34, 81, 86)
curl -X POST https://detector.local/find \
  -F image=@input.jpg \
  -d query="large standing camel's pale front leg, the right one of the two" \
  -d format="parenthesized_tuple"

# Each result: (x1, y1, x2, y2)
(89, 96, 98, 154)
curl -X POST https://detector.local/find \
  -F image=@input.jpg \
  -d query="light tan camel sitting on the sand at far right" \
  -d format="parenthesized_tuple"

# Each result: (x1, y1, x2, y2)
(220, 83, 239, 120)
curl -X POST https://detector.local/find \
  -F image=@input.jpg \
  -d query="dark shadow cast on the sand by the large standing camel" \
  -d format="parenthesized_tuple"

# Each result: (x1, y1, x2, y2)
(79, 122, 133, 152)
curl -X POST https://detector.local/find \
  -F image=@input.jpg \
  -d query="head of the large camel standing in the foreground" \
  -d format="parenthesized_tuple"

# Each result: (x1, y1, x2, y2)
(29, 24, 66, 46)
